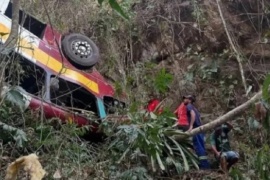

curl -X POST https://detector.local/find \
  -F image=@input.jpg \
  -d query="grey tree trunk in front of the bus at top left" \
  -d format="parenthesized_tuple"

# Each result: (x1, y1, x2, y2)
(0, 0, 20, 54)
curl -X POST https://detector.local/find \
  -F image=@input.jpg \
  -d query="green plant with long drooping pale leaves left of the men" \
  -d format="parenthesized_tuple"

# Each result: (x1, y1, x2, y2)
(103, 112, 198, 174)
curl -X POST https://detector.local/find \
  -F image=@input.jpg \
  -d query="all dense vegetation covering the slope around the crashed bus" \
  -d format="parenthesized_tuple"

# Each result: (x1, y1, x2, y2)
(0, 0, 270, 180)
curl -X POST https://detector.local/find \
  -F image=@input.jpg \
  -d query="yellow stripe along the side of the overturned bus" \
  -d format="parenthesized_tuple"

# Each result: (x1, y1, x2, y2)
(0, 23, 99, 93)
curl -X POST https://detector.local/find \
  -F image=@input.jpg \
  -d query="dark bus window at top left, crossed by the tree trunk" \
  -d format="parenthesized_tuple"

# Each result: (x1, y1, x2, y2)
(5, 2, 46, 38)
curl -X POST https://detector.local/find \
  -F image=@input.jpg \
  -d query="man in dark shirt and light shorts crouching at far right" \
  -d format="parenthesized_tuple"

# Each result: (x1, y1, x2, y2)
(210, 122, 239, 173)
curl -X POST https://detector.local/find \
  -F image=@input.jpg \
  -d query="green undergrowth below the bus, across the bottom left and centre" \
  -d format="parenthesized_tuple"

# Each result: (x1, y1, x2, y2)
(0, 99, 197, 179)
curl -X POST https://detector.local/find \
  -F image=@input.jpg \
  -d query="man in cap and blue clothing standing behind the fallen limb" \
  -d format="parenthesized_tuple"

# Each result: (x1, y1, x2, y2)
(183, 95, 210, 169)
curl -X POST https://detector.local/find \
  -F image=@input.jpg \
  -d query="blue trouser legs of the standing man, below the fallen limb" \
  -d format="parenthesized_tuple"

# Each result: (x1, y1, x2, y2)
(192, 134, 210, 169)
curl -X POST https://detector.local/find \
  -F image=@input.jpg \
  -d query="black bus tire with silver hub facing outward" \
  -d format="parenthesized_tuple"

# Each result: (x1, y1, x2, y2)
(62, 33, 100, 69)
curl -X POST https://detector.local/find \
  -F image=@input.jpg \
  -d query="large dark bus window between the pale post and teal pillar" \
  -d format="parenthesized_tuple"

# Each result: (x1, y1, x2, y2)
(50, 76, 98, 115)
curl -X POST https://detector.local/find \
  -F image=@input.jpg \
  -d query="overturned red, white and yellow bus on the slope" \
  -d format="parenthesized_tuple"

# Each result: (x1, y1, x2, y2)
(0, 0, 125, 129)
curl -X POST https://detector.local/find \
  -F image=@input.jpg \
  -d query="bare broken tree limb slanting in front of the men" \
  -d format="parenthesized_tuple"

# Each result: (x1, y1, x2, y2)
(175, 91, 262, 140)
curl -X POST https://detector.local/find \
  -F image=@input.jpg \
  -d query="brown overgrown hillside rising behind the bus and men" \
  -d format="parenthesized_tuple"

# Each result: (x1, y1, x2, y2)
(26, 0, 270, 118)
